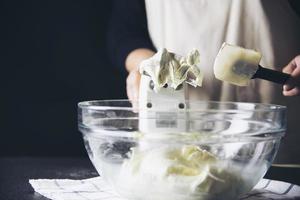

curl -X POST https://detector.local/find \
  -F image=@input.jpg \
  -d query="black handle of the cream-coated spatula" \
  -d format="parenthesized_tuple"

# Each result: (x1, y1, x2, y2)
(252, 65, 291, 85)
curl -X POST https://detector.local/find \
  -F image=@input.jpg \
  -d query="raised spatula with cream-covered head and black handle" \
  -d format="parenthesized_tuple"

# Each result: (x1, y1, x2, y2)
(214, 43, 290, 86)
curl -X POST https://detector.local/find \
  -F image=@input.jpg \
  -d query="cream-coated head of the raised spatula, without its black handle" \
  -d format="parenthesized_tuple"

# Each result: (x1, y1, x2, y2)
(214, 43, 261, 86)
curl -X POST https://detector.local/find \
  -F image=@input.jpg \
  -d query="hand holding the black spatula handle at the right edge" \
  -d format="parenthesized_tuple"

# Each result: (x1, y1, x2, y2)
(282, 55, 300, 96)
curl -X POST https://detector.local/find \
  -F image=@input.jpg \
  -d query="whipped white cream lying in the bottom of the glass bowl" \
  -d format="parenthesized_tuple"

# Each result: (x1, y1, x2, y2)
(119, 145, 246, 200)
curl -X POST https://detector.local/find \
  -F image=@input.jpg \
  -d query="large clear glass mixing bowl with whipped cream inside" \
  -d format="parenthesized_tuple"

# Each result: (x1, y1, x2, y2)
(78, 100, 286, 200)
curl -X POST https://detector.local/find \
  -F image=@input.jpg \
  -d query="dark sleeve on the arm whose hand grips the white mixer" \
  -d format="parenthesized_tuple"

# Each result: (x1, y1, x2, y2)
(107, 0, 155, 71)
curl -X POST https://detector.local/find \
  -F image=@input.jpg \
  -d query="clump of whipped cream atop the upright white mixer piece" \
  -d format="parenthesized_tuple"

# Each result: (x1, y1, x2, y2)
(139, 49, 203, 91)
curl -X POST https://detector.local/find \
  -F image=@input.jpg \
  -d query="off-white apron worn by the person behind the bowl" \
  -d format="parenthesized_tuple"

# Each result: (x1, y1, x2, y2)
(145, 0, 300, 163)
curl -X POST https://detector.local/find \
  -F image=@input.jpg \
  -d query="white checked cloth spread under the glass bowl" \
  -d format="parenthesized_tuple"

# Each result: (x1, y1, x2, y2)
(29, 177, 300, 200)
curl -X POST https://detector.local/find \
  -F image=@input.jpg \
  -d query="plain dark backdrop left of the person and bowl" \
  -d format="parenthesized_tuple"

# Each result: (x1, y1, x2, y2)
(0, 0, 126, 156)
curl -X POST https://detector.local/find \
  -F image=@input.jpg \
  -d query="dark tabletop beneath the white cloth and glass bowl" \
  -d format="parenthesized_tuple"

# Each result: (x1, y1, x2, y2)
(0, 157, 300, 200)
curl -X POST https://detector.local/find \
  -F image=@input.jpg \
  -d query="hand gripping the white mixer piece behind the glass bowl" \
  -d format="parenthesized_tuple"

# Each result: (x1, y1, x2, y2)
(125, 49, 154, 101)
